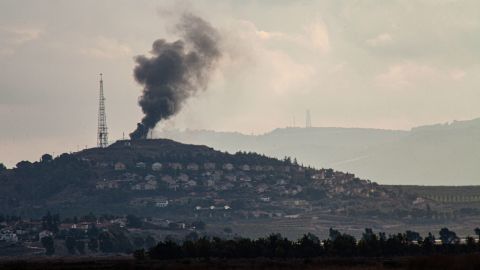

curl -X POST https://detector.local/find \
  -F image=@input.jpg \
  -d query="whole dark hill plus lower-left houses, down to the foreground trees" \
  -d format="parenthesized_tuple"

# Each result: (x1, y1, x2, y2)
(0, 139, 480, 253)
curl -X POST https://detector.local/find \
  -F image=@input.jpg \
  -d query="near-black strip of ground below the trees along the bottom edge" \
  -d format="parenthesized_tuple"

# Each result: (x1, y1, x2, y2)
(0, 254, 480, 270)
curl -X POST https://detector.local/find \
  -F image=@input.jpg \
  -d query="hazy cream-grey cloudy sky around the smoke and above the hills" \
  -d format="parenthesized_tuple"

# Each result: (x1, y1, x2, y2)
(0, 0, 480, 166)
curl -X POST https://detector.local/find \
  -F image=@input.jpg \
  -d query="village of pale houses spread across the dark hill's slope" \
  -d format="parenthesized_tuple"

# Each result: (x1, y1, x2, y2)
(81, 141, 412, 221)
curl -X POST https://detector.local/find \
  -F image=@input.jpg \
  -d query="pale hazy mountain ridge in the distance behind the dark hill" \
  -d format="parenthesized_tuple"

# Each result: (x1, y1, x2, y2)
(157, 118, 480, 185)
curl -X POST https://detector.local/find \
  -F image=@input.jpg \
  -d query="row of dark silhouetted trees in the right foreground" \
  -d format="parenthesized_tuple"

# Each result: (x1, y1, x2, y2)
(139, 228, 480, 260)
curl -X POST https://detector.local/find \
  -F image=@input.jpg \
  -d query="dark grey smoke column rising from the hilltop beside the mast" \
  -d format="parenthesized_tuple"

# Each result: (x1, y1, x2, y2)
(130, 14, 221, 139)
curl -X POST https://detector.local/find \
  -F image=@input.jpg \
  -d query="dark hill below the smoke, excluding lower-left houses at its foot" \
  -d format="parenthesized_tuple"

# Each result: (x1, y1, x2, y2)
(0, 139, 454, 235)
